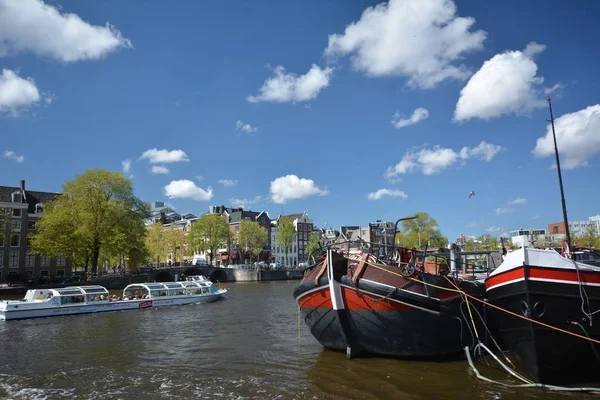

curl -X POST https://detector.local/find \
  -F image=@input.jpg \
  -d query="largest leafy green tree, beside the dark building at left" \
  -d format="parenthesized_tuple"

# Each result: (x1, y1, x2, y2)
(31, 169, 149, 273)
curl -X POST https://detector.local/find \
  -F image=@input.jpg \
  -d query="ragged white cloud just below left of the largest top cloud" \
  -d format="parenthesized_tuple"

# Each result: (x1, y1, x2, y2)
(248, 64, 333, 103)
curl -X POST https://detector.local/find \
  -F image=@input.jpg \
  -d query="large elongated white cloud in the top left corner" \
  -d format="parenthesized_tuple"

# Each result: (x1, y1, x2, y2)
(0, 0, 131, 62)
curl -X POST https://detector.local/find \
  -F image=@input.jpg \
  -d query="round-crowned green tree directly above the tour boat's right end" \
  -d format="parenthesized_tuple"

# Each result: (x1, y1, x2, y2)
(188, 214, 230, 263)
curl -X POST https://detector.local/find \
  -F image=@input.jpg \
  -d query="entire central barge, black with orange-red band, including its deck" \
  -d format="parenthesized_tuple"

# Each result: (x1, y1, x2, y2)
(294, 249, 485, 358)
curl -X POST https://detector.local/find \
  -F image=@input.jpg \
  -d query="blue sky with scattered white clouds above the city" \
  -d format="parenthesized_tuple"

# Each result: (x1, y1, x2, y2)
(0, 0, 600, 240)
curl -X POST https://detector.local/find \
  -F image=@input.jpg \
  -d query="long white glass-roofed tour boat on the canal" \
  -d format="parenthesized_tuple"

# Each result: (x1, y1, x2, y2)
(0, 277, 227, 320)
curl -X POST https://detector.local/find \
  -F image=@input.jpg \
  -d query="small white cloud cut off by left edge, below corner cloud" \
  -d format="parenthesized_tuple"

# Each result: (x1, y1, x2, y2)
(0, 69, 41, 116)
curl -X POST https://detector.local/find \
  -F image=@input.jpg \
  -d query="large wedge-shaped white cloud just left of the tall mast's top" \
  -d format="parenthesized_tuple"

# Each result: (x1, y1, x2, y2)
(454, 42, 546, 121)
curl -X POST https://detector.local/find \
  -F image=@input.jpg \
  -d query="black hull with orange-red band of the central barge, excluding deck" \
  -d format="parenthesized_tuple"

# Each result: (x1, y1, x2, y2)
(294, 277, 483, 359)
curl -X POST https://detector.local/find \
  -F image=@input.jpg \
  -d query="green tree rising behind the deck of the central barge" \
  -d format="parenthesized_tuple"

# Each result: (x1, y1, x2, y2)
(396, 212, 448, 248)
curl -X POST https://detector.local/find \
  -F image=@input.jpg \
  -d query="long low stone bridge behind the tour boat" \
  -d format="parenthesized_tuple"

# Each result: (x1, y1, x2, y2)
(148, 266, 302, 283)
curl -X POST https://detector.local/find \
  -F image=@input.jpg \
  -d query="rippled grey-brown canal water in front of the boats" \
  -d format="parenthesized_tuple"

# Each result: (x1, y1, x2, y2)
(0, 282, 589, 399)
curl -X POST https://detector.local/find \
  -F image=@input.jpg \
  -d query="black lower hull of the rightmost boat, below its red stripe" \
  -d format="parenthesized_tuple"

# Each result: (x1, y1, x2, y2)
(488, 281, 600, 385)
